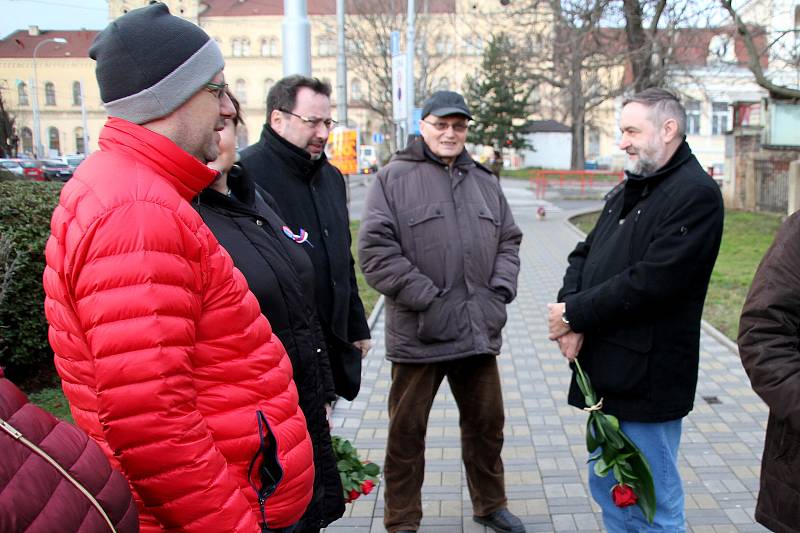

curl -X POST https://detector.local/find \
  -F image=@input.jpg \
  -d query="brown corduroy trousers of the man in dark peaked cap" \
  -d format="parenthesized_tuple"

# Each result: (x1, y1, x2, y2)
(383, 355, 507, 532)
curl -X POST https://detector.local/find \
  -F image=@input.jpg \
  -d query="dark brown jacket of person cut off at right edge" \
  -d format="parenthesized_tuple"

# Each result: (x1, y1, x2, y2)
(739, 213, 800, 533)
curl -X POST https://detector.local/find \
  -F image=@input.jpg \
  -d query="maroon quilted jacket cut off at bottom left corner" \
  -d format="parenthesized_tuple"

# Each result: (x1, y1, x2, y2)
(0, 368, 139, 533)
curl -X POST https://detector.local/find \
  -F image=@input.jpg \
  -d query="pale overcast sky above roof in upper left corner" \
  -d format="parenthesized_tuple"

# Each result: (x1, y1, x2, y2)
(0, 0, 108, 38)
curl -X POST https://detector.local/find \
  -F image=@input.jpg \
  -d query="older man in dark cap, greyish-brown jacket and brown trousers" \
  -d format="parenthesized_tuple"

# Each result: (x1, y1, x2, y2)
(358, 91, 525, 533)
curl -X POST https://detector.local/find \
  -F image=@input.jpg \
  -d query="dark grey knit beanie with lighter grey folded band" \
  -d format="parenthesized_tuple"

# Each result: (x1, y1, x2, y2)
(89, 3, 225, 124)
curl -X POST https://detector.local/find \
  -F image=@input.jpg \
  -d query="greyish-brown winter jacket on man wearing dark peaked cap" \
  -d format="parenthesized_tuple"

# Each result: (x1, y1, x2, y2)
(358, 139, 522, 363)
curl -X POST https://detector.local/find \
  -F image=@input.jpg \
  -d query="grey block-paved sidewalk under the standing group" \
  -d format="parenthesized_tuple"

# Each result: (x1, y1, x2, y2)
(326, 184, 767, 533)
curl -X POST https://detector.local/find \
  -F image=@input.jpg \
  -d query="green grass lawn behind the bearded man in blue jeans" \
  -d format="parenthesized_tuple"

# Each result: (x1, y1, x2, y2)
(571, 211, 781, 340)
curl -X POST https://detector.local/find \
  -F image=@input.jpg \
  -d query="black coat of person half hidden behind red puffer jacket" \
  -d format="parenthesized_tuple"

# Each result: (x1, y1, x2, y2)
(192, 166, 344, 532)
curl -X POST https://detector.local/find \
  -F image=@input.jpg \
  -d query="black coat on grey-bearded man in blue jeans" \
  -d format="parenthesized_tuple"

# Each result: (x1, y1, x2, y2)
(558, 141, 724, 422)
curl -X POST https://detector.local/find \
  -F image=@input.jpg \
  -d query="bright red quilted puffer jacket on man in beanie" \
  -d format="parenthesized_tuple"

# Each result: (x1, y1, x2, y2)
(44, 118, 314, 532)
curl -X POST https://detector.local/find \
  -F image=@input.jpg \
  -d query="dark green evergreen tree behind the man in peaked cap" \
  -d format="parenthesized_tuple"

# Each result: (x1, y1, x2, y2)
(464, 33, 533, 150)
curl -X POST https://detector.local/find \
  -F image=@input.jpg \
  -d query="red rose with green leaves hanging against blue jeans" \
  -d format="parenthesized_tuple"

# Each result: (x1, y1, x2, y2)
(573, 359, 656, 523)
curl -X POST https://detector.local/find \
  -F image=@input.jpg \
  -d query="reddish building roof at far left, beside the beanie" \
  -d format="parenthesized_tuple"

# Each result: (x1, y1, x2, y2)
(0, 30, 99, 59)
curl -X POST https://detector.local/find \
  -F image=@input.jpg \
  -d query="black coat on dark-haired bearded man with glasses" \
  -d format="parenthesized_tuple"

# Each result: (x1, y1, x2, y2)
(241, 124, 370, 399)
